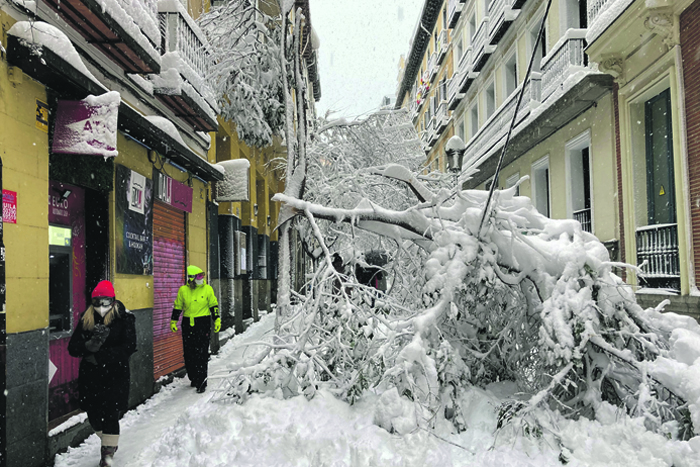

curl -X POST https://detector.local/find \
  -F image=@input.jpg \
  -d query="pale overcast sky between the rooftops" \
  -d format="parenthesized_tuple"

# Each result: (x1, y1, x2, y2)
(309, 0, 424, 119)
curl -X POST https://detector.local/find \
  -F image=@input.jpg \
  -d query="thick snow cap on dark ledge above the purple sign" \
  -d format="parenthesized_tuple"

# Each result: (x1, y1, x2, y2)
(7, 21, 107, 90)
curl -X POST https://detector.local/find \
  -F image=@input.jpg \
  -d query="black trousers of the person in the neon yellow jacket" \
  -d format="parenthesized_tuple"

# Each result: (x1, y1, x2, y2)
(182, 316, 211, 387)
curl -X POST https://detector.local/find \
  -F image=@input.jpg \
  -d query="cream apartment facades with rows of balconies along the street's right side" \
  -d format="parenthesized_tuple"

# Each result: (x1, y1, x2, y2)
(397, 0, 697, 314)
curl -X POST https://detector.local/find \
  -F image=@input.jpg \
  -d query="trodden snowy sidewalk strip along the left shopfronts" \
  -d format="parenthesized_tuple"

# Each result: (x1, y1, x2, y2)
(55, 314, 275, 467)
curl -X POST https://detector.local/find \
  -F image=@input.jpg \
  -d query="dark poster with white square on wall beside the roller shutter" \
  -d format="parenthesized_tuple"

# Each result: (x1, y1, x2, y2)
(114, 165, 153, 276)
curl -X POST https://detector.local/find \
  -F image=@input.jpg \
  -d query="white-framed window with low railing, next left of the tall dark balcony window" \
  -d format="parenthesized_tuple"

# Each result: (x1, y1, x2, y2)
(566, 132, 593, 232)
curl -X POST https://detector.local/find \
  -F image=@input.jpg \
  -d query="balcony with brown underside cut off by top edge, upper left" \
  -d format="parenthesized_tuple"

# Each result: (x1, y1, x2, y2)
(46, 0, 161, 73)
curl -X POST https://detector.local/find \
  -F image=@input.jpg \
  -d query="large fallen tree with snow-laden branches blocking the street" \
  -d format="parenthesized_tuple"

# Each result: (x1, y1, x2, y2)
(215, 109, 700, 446)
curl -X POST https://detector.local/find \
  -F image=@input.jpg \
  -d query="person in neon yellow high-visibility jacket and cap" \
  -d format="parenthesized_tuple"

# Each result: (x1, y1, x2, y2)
(170, 265, 221, 393)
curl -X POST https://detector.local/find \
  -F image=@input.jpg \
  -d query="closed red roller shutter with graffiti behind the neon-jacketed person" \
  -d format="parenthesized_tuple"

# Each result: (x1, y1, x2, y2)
(153, 201, 185, 379)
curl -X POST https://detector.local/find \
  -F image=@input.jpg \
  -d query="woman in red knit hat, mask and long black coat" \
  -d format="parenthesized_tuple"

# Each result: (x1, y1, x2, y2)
(68, 281, 136, 467)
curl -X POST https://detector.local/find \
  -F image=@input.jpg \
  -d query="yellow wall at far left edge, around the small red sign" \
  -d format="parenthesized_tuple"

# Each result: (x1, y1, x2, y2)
(0, 22, 49, 333)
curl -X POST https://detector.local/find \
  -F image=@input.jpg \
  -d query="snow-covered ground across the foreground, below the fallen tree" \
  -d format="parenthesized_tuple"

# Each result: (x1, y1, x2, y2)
(50, 315, 700, 467)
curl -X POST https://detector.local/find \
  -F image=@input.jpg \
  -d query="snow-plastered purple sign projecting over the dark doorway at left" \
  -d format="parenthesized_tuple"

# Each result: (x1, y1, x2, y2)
(51, 91, 120, 157)
